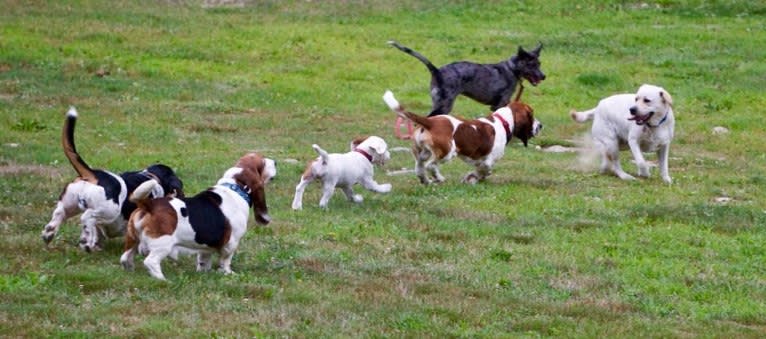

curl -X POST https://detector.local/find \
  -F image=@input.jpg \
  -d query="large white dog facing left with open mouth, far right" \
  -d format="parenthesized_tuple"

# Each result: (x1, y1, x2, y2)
(570, 85, 676, 184)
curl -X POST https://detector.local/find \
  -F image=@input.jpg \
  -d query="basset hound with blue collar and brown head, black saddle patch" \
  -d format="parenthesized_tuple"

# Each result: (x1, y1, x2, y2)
(120, 153, 277, 280)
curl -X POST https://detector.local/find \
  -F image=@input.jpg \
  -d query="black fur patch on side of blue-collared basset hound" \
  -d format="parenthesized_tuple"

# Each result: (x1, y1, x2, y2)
(182, 191, 231, 248)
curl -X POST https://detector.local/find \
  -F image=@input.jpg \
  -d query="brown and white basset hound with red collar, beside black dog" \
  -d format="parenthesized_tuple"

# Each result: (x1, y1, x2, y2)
(383, 90, 542, 184)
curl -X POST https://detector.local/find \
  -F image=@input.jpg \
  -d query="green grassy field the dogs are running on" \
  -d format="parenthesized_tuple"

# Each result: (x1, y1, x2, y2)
(0, 0, 766, 338)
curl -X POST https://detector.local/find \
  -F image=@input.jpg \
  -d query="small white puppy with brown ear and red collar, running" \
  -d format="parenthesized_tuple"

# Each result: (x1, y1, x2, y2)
(292, 136, 391, 210)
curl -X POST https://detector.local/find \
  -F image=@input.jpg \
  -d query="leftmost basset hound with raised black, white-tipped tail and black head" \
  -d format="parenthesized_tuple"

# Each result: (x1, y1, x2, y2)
(42, 107, 183, 252)
